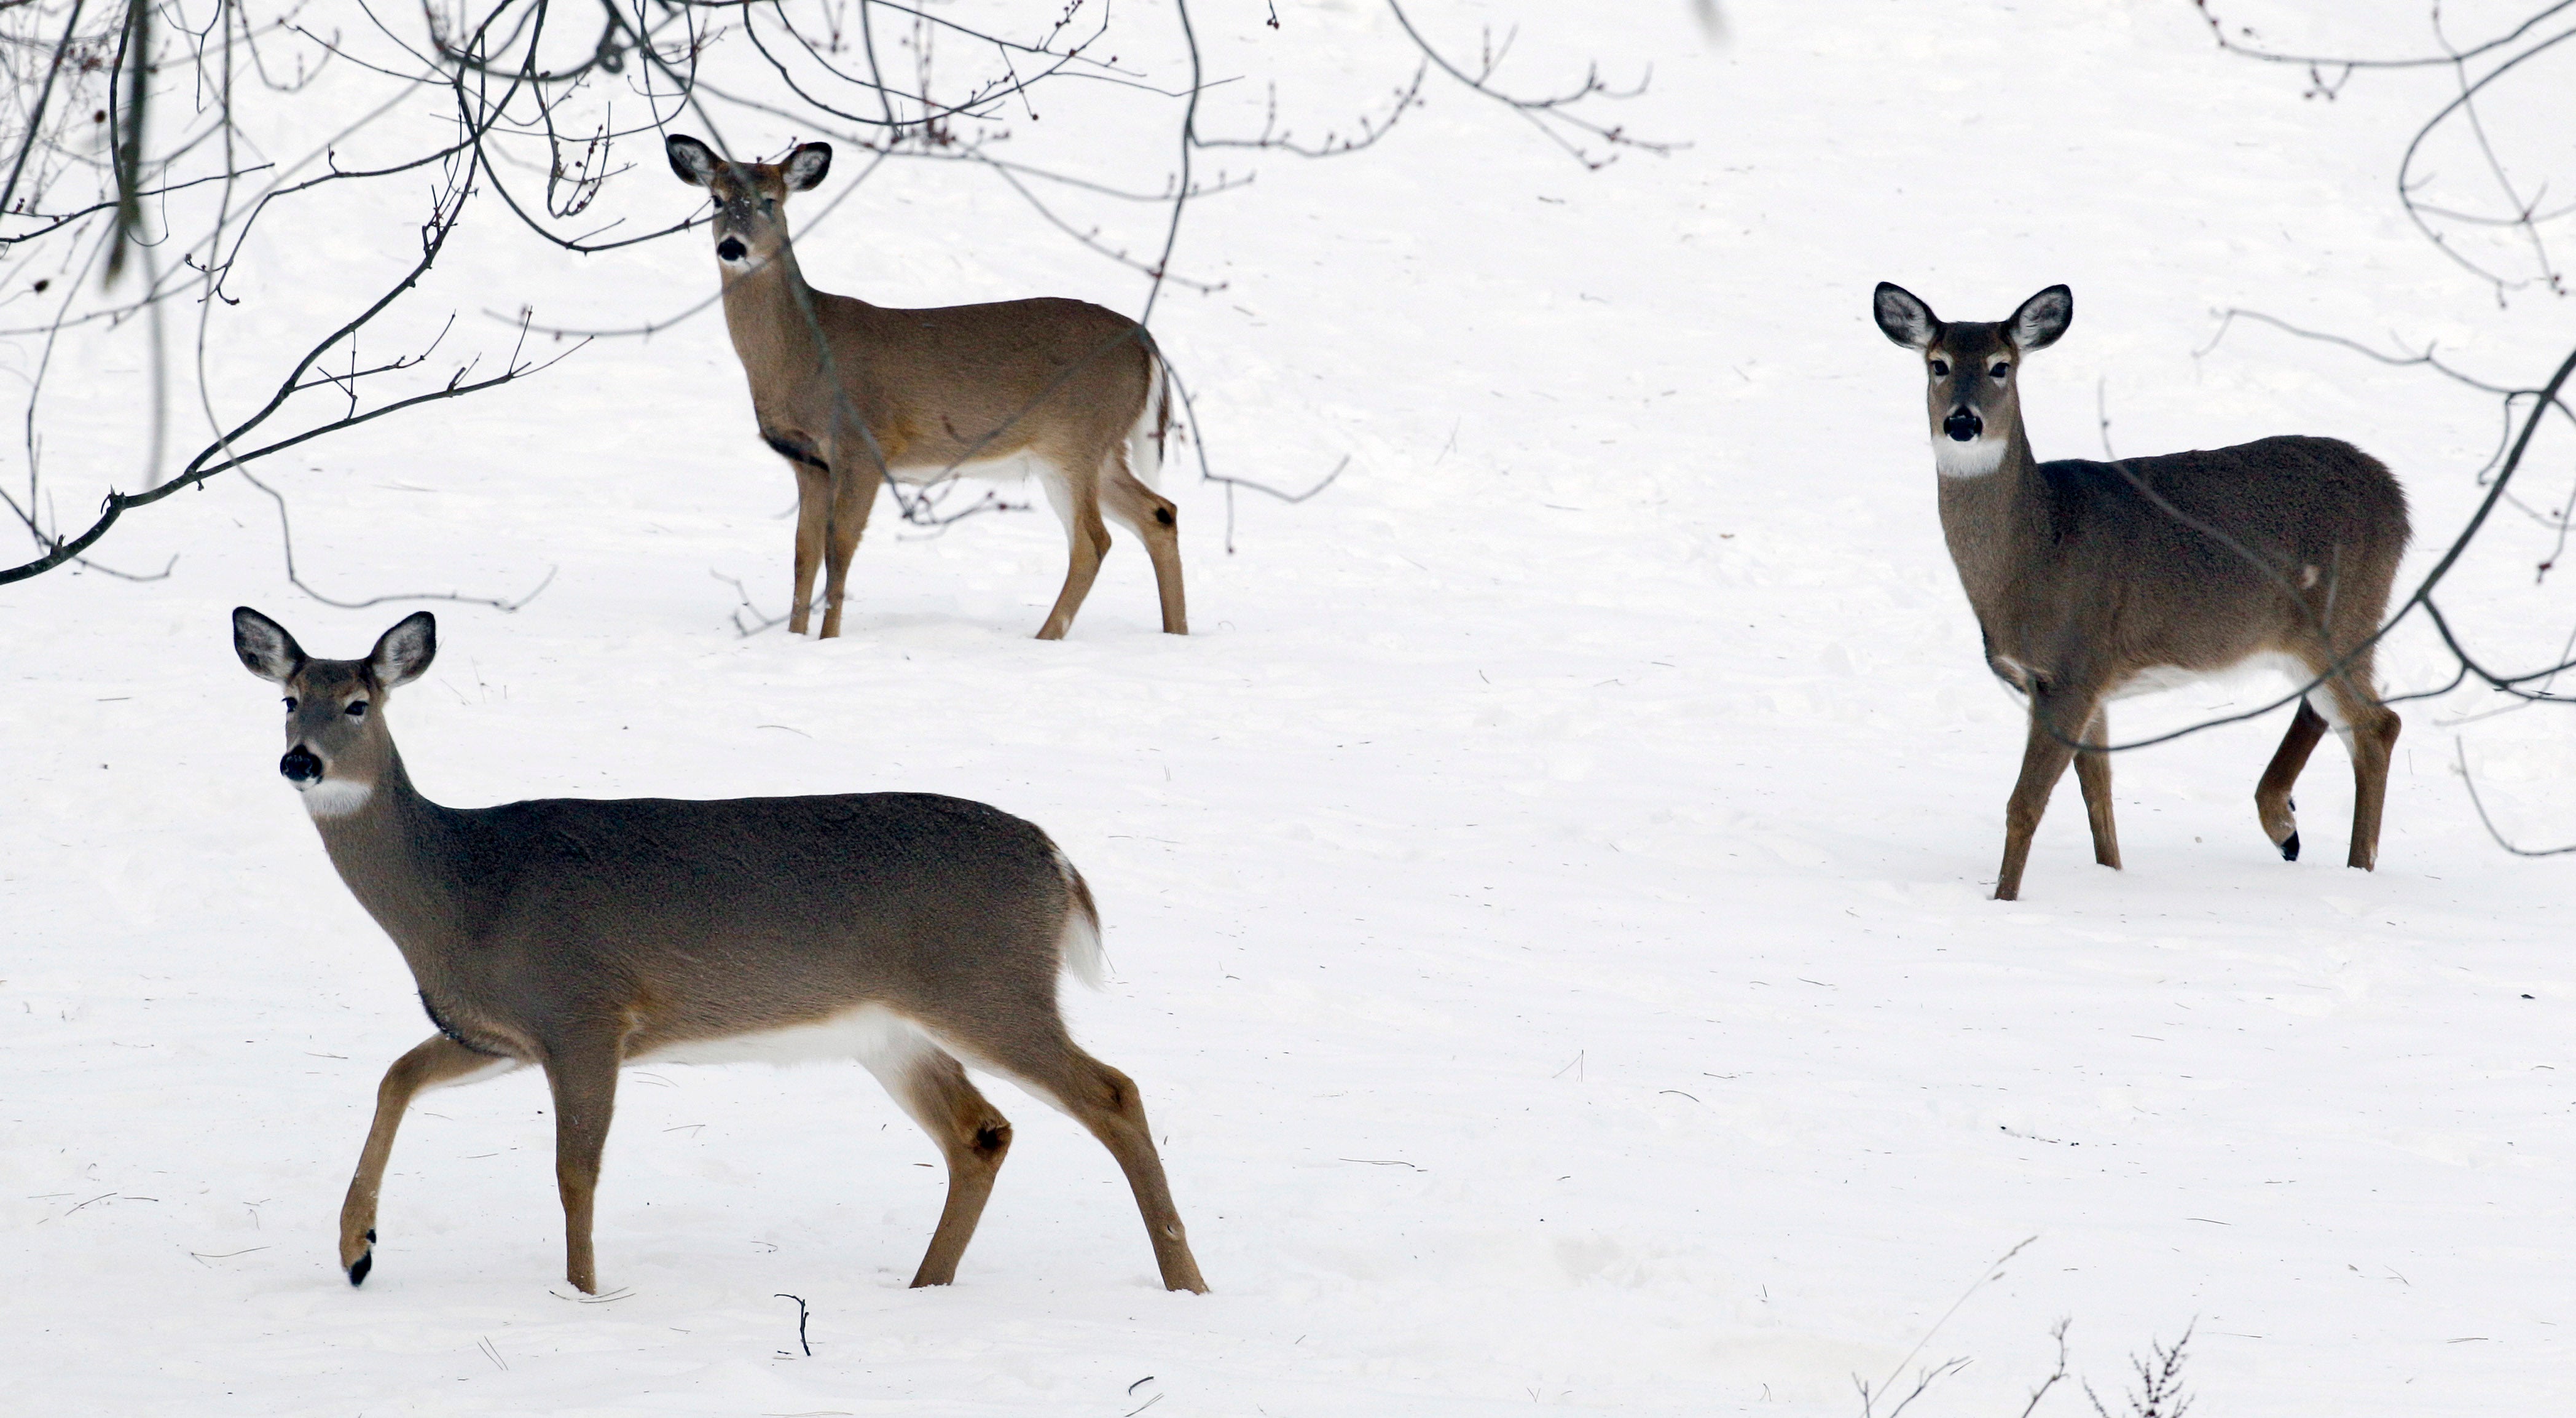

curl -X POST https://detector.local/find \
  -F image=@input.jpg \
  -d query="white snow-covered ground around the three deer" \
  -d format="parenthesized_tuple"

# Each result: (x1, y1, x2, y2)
(0, 0, 2576, 1418)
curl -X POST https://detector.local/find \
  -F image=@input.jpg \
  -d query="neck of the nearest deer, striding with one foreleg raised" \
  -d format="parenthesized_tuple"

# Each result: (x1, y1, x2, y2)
(307, 744, 469, 967)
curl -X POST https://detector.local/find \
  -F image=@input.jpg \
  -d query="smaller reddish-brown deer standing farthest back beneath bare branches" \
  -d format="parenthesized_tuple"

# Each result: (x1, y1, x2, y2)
(665, 134, 1190, 641)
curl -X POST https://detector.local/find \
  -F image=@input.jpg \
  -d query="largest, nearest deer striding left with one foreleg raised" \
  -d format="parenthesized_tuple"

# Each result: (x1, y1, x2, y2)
(232, 605, 1208, 1295)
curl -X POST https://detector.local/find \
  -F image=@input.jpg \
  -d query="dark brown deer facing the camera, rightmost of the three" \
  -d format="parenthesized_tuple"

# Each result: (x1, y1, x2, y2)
(1873, 281, 2409, 901)
